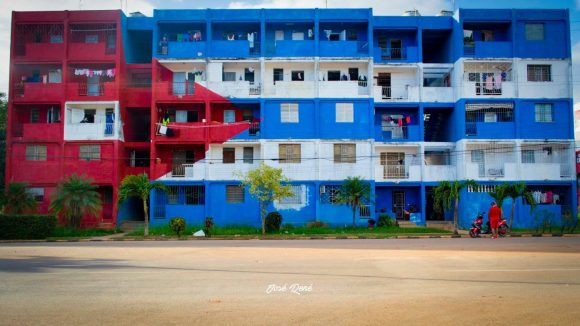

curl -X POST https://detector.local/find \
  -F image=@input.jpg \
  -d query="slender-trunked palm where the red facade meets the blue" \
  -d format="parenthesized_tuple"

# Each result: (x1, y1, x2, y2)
(119, 173, 165, 236)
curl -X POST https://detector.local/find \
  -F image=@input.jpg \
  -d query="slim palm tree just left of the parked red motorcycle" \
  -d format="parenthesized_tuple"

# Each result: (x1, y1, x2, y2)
(433, 180, 477, 234)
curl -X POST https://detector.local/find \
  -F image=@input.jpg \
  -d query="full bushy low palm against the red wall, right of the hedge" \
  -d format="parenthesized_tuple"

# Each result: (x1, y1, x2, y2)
(49, 174, 101, 229)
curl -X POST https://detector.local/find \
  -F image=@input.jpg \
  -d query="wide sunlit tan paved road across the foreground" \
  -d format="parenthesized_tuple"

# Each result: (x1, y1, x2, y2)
(0, 238, 580, 325)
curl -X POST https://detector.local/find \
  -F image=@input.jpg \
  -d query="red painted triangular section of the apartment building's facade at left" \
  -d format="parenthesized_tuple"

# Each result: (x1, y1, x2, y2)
(6, 10, 249, 227)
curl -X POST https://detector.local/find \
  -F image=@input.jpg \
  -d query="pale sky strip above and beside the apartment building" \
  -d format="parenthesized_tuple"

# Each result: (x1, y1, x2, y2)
(0, 0, 580, 100)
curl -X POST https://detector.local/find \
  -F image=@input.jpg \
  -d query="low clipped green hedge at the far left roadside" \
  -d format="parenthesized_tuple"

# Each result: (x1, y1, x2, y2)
(0, 215, 56, 240)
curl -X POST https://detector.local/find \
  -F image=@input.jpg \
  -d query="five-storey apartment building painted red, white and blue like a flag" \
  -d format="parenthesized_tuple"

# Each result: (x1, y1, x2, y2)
(6, 9, 577, 227)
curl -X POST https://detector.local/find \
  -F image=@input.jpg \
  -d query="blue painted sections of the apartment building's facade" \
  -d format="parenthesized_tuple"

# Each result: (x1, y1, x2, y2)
(118, 9, 577, 228)
